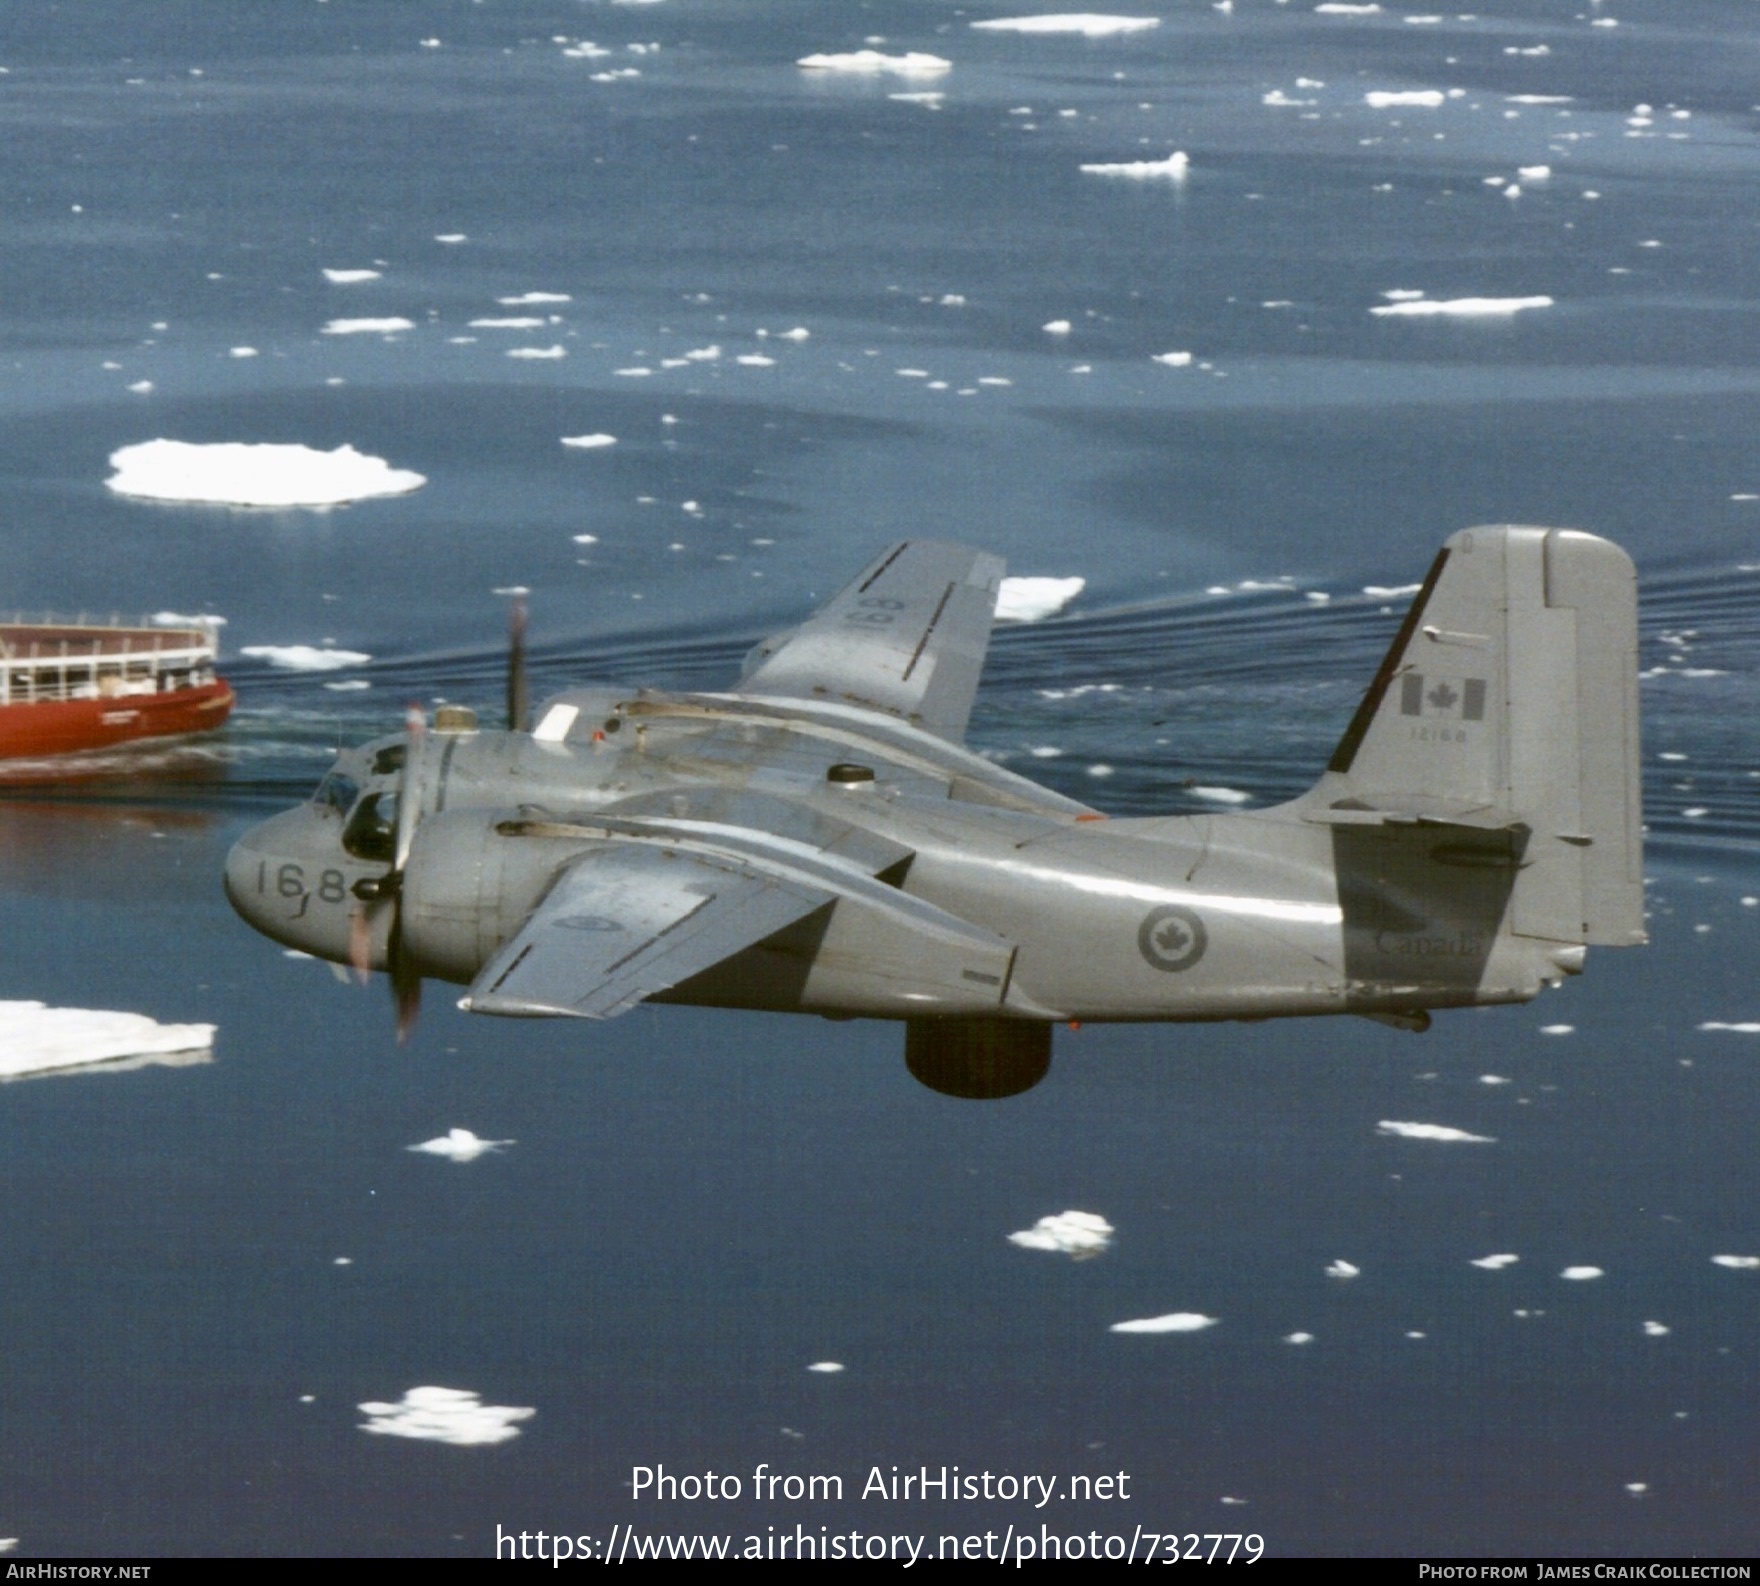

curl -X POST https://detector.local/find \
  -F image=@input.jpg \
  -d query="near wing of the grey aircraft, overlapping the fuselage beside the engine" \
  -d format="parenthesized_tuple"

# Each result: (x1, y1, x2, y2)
(463, 841, 834, 1019)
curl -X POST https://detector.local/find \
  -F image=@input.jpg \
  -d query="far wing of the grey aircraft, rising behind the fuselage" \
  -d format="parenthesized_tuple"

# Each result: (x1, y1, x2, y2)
(736, 540, 1005, 743)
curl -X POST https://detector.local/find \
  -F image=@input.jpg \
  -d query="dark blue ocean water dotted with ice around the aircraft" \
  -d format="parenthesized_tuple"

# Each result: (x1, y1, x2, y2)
(0, 0, 1760, 1556)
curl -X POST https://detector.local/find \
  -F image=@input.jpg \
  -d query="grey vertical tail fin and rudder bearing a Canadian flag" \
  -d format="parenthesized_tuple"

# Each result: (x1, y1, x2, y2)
(1304, 526, 1644, 947)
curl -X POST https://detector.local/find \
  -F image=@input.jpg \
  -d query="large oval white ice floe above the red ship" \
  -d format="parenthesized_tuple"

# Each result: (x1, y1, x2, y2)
(106, 440, 428, 507)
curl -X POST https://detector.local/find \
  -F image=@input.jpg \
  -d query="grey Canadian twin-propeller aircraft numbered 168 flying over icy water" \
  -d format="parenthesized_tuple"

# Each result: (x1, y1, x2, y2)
(227, 526, 1644, 1097)
